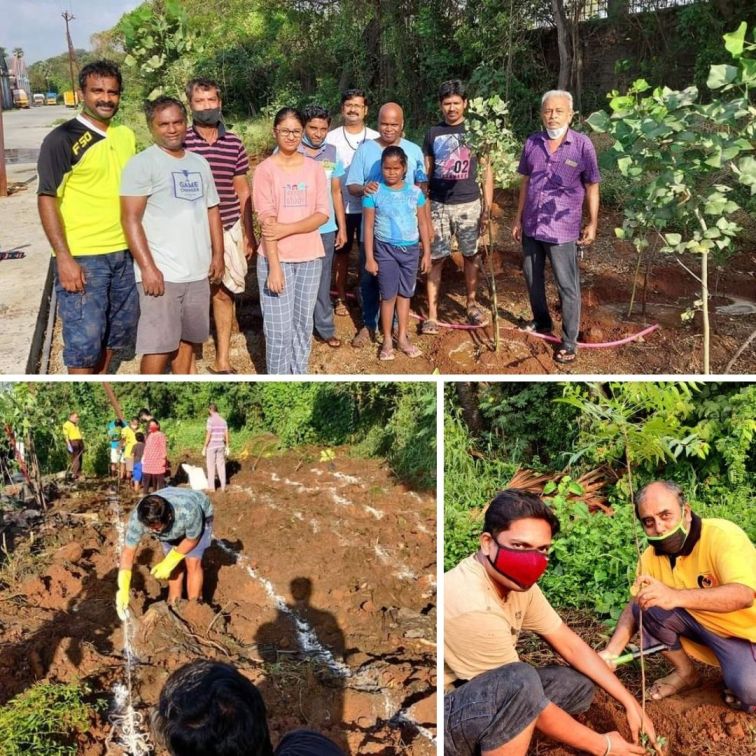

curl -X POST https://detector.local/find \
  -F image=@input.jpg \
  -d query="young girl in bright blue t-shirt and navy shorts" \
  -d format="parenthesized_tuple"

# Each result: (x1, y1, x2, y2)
(362, 146, 431, 360)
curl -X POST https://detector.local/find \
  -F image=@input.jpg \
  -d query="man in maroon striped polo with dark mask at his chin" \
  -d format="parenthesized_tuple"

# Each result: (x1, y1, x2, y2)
(184, 78, 257, 375)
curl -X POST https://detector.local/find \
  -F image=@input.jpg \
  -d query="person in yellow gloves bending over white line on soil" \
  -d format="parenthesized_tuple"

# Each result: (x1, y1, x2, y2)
(116, 486, 213, 620)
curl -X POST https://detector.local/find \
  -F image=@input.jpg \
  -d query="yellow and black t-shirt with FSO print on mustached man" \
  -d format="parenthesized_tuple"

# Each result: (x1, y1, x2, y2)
(37, 115, 136, 257)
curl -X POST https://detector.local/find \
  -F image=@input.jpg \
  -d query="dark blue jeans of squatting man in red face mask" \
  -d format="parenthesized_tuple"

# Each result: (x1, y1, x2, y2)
(444, 662, 593, 756)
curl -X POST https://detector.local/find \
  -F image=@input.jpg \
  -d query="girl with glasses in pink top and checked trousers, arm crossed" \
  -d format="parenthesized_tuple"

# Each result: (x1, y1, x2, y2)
(252, 108, 329, 375)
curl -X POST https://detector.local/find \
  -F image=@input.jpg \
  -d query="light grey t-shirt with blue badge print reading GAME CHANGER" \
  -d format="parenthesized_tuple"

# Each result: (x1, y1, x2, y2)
(121, 144, 219, 283)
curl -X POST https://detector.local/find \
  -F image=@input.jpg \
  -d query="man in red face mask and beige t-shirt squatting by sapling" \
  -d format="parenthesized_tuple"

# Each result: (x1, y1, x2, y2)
(444, 488, 655, 756)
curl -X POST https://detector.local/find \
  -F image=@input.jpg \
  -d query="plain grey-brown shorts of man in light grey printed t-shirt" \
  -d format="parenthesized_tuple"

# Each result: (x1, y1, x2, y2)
(136, 278, 210, 354)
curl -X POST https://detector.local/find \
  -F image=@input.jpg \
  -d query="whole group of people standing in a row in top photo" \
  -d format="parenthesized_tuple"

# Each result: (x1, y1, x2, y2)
(38, 61, 600, 374)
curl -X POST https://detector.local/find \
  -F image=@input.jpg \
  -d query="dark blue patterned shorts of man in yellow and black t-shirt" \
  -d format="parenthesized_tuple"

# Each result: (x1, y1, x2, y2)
(55, 249, 139, 368)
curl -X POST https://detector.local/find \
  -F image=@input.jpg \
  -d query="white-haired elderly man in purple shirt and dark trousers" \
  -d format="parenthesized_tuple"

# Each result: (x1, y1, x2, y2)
(512, 90, 601, 363)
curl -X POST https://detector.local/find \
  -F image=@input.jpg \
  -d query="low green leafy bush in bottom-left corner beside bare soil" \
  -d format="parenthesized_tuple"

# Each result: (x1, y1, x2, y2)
(0, 682, 101, 756)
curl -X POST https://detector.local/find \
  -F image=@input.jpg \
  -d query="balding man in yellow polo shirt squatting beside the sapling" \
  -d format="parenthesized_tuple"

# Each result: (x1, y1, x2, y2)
(601, 481, 756, 712)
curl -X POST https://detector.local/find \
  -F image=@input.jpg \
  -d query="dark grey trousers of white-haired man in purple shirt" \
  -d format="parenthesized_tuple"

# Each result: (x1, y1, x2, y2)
(522, 234, 580, 349)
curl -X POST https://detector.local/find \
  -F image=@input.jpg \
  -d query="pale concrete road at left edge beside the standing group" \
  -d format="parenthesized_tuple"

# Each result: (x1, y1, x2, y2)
(0, 105, 67, 376)
